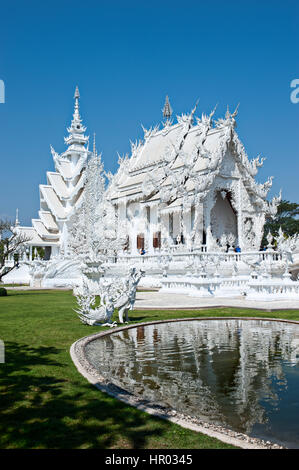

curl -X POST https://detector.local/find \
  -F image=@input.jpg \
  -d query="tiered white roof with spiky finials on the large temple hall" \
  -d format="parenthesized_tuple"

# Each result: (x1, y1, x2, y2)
(108, 101, 278, 215)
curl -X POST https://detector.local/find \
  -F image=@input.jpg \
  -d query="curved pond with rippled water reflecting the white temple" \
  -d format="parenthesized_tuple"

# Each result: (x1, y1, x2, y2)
(86, 319, 299, 448)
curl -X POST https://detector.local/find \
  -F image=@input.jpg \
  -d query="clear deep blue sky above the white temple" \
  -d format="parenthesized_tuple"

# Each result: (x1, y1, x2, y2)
(0, 0, 299, 224)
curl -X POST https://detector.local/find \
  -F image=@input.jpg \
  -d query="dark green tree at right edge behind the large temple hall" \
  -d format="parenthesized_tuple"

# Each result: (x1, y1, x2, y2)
(262, 200, 299, 245)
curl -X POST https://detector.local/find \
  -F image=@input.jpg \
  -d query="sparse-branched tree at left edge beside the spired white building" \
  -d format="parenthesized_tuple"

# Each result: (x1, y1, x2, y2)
(0, 219, 30, 282)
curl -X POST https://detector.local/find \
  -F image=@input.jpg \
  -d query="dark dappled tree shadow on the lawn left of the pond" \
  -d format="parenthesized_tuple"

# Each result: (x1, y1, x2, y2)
(0, 342, 168, 448)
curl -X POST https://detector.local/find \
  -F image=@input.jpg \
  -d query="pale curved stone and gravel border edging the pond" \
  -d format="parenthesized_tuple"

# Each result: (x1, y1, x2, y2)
(70, 317, 299, 449)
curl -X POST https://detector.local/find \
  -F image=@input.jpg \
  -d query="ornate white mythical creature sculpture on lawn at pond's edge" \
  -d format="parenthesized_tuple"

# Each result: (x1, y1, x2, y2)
(75, 268, 144, 327)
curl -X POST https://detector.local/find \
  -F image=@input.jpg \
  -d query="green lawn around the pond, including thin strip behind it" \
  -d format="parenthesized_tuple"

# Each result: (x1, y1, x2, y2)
(0, 290, 299, 449)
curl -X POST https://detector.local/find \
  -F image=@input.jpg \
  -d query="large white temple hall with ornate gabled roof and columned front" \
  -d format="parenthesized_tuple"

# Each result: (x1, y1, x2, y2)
(107, 100, 280, 253)
